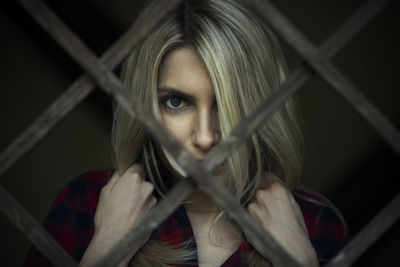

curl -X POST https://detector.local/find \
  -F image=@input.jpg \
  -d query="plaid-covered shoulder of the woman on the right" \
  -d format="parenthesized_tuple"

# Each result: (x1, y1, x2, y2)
(292, 187, 350, 263)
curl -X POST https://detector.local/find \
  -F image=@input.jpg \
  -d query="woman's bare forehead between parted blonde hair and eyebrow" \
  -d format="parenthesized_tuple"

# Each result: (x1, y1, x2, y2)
(158, 47, 214, 97)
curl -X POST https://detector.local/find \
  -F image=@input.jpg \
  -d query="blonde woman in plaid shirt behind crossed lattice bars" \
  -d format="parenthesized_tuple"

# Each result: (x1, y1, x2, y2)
(28, 0, 347, 266)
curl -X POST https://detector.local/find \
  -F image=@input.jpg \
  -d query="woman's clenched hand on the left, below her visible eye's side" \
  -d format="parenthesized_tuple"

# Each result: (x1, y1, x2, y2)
(80, 164, 156, 266)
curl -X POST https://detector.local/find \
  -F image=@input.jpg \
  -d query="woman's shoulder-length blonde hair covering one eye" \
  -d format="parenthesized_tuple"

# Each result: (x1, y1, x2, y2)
(112, 0, 302, 266)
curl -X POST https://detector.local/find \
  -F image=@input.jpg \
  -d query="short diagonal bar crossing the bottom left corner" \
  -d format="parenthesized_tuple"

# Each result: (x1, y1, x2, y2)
(0, 185, 78, 267)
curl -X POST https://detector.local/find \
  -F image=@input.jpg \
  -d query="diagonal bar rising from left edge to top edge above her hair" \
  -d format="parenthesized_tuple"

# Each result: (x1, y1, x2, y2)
(0, 0, 185, 180)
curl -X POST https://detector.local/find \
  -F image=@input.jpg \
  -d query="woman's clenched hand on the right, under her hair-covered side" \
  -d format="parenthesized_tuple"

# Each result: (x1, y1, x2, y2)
(248, 173, 319, 266)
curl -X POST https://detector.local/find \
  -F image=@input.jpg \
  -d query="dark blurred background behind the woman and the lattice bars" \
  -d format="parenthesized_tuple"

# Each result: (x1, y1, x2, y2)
(0, 0, 400, 266)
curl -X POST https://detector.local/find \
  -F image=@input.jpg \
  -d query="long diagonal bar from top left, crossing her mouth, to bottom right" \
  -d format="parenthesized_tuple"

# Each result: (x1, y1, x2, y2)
(20, 0, 299, 266)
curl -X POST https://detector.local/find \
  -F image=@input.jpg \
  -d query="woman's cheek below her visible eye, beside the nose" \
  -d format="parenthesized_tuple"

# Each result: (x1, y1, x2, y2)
(161, 113, 192, 145)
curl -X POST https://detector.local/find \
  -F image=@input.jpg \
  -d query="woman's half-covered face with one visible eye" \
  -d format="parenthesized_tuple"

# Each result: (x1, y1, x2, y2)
(158, 47, 220, 164)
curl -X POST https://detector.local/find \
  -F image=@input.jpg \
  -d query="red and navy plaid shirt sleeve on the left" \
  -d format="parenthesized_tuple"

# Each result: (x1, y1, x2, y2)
(24, 171, 109, 266)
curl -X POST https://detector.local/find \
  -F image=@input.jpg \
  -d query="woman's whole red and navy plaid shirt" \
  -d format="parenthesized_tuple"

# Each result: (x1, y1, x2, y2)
(25, 171, 349, 267)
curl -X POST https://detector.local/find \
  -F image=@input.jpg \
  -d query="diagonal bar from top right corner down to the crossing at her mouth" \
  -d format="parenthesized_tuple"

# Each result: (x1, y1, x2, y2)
(205, 0, 389, 170)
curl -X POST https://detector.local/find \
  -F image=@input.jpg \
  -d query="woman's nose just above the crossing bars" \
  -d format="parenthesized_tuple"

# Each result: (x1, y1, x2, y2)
(192, 110, 220, 153)
